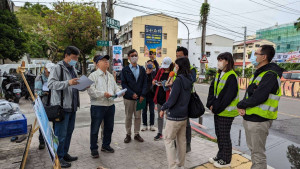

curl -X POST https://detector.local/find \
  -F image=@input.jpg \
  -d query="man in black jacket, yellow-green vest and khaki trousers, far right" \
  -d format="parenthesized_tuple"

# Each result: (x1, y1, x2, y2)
(237, 45, 283, 169)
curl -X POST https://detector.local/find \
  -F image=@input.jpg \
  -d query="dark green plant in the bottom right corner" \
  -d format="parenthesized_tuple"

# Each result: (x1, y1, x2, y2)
(287, 144, 300, 169)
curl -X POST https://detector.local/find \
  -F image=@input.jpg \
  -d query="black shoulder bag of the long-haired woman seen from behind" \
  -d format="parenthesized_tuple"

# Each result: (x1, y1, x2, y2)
(178, 76, 205, 118)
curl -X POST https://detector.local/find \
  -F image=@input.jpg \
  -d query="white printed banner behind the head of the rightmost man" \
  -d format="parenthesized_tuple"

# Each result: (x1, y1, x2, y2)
(272, 51, 300, 63)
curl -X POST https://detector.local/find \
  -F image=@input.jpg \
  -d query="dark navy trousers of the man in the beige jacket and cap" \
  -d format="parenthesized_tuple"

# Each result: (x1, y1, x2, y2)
(90, 105, 115, 150)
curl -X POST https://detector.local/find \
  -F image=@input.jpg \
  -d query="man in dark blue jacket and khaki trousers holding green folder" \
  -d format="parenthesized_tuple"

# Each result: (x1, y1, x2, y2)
(121, 49, 147, 143)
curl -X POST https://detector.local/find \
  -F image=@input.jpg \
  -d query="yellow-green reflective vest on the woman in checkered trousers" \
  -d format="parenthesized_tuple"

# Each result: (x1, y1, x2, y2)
(214, 70, 239, 117)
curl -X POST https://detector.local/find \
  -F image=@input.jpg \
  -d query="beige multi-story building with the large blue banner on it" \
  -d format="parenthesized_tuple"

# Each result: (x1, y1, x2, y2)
(117, 14, 178, 65)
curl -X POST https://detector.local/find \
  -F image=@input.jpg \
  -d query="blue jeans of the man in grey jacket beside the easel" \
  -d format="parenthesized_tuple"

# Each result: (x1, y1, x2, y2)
(54, 112, 76, 159)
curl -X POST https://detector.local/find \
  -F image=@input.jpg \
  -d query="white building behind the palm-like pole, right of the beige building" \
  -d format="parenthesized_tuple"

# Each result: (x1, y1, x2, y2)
(177, 34, 234, 68)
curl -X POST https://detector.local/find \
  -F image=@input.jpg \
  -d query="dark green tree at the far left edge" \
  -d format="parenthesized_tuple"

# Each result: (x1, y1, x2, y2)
(0, 10, 27, 63)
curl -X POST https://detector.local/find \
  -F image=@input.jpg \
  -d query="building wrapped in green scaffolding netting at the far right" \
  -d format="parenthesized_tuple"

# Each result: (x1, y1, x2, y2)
(256, 23, 300, 53)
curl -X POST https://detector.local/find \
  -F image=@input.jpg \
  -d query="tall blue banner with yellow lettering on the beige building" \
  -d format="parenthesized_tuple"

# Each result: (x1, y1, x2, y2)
(144, 25, 162, 57)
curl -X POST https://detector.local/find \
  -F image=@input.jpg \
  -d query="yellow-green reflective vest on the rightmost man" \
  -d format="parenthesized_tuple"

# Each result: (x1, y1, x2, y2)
(246, 70, 281, 120)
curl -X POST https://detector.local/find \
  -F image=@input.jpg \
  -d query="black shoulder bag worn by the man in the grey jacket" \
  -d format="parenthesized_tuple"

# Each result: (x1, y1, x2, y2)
(45, 64, 65, 122)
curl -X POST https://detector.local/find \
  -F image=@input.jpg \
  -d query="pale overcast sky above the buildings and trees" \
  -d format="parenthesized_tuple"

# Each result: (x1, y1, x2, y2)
(13, 0, 300, 41)
